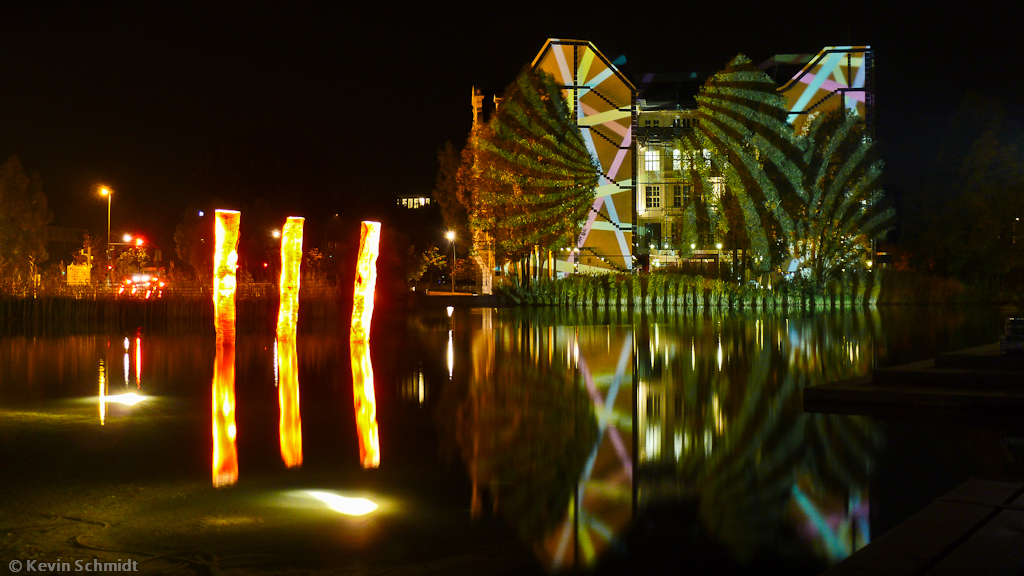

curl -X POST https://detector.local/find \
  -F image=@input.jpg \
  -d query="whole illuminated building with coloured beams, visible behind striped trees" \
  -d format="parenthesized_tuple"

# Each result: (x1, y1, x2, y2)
(464, 42, 874, 270)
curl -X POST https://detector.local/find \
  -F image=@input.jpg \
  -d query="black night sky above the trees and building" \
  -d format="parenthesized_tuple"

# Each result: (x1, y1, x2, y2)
(0, 0, 1024, 248)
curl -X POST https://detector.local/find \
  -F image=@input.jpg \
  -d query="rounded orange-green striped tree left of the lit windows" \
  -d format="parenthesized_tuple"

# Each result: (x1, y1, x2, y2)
(470, 67, 598, 259)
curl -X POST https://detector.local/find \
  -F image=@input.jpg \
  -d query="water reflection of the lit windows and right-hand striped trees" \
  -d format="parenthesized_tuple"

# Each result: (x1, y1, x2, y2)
(637, 314, 880, 561)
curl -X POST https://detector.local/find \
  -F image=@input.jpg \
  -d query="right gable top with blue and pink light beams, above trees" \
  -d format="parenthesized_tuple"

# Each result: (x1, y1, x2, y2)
(761, 46, 874, 133)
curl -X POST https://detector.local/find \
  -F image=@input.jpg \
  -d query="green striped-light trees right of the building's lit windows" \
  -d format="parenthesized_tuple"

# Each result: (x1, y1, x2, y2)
(676, 54, 893, 284)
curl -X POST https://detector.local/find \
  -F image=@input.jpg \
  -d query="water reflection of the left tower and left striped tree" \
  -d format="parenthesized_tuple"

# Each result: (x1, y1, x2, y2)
(438, 310, 632, 569)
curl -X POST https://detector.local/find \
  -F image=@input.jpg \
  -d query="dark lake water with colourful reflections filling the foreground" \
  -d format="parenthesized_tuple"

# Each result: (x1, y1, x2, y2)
(0, 307, 1019, 574)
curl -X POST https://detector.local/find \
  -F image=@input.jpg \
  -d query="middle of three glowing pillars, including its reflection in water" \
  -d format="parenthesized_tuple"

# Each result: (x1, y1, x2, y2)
(276, 216, 304, 468)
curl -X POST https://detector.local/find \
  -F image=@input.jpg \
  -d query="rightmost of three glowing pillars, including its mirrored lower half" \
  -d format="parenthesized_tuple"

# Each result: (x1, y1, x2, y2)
(349, 221, 381, 468)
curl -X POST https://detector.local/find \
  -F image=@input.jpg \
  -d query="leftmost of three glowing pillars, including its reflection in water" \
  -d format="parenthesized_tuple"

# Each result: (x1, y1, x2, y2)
(213, 210, 242, 487)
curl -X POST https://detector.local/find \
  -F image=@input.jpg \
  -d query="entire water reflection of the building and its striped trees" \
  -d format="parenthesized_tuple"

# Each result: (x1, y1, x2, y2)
(436, 308, 881, 569)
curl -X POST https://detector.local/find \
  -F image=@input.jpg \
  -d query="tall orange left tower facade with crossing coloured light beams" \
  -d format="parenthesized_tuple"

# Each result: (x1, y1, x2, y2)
(532, 38, 635, 273)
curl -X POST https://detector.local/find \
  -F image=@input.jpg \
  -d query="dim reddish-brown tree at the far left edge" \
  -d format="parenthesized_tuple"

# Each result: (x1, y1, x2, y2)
(0, 156, 53, 278)
